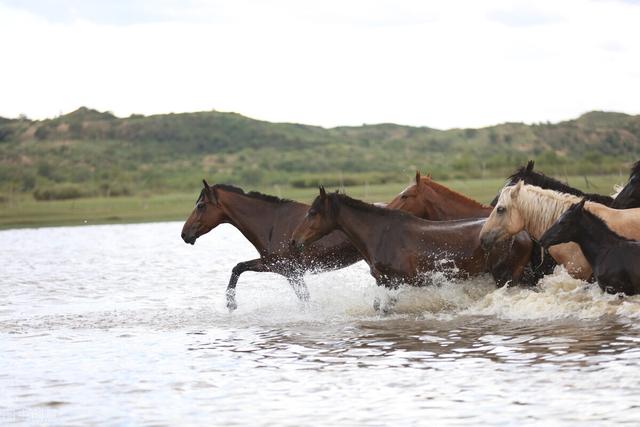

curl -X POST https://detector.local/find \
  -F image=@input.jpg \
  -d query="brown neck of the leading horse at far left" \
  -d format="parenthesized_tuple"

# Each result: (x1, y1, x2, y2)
(217, 189, 286, 255)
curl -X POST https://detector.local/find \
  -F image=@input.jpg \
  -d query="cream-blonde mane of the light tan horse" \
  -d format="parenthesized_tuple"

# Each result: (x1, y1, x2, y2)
(496, 185, 582, 238)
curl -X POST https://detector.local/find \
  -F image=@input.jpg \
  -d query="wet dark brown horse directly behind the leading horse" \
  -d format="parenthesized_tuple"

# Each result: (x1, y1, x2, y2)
(291, 187, 531, 287)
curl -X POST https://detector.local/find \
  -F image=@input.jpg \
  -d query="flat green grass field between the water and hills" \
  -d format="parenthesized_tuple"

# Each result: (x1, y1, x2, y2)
(0, 175, 625, 229)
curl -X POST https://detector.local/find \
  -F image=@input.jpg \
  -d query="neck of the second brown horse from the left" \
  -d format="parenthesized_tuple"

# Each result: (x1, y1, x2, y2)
(335, 201, 398, 265)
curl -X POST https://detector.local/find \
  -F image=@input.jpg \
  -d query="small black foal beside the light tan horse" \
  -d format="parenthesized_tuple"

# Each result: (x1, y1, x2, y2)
(540, 199, 640, 295)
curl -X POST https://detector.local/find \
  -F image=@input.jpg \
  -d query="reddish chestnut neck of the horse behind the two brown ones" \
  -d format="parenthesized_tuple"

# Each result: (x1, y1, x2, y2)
(426, 183, 493, 221)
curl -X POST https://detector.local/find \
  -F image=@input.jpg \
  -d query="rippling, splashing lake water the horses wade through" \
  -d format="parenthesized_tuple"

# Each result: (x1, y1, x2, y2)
(0, 222, 640, 426)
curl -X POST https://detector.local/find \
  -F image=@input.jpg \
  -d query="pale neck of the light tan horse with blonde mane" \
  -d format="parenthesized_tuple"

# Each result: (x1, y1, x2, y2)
(515, 194, 579, 239)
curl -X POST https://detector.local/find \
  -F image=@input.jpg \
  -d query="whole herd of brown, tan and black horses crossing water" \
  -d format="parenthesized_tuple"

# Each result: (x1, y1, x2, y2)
(182, 161, 640, 310)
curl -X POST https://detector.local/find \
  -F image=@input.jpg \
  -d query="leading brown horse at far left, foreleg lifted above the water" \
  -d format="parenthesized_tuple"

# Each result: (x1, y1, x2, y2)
(182, 180, 360, 310)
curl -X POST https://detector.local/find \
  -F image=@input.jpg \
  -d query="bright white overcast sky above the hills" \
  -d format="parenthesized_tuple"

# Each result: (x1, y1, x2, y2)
(0, 0, 640, 128)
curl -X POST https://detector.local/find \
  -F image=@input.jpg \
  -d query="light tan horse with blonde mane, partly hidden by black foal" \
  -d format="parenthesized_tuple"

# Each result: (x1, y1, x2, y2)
(480, 181, 640, 280)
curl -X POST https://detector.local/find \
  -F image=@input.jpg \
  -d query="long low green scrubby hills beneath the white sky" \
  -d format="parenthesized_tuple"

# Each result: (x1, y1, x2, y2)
(0, 107, 640, 198)
